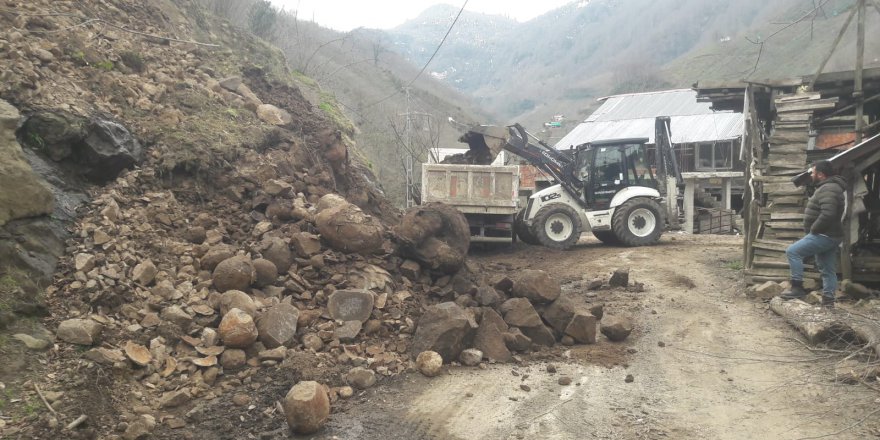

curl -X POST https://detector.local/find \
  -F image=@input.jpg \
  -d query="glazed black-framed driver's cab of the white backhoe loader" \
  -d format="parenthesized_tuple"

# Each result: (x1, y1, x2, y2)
(574, 138, 657, 210)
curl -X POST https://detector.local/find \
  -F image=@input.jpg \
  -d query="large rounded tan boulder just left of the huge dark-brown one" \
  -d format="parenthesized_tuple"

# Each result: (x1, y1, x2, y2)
(315, 196, 383, 255)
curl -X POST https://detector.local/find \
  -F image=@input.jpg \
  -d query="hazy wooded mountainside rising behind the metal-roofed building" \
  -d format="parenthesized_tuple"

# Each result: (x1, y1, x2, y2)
(387, 0, 880, 137)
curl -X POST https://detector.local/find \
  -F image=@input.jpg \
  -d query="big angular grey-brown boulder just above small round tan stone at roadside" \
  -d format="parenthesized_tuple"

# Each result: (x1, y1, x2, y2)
(411, 302, 477, 362)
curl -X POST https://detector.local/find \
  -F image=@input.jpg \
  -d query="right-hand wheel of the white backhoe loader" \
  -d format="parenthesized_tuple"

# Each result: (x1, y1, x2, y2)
(611, 197, 666, 246)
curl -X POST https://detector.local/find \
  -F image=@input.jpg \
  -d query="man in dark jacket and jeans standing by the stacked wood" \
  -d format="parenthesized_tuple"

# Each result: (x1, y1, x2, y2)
(782, 160, 846, 307)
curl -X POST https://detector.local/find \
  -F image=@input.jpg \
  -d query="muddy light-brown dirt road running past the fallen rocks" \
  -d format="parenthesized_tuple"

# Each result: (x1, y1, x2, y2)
(315, 234, 880, 440)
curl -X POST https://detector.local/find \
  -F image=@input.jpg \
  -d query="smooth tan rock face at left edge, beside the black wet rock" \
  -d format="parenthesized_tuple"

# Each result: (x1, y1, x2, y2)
(0, 100, 55, 226)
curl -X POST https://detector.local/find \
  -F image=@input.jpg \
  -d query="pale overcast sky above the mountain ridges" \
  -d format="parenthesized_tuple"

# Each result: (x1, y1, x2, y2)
(270, 0, 573, 31)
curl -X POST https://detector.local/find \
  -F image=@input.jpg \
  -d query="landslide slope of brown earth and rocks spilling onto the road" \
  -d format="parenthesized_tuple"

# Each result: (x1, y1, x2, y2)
(0, 0, 628, 439)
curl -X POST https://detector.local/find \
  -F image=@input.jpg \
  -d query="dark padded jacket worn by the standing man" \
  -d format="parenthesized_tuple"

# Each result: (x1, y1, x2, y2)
(804, 176, 846, 240)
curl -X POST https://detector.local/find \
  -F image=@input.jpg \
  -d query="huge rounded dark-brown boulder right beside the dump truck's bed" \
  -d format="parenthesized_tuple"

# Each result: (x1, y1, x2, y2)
(394, 203, 471, 274)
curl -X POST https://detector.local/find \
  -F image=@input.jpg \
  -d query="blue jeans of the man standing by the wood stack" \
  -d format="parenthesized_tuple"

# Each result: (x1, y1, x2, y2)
(785, 234, 840, 299)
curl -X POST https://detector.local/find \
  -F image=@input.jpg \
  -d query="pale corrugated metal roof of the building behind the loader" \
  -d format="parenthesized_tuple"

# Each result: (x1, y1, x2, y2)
(555, 89, 743, 149)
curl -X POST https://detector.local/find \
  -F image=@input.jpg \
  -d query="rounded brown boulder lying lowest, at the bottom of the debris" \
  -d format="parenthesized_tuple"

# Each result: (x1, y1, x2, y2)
(281, 381, 330, 434)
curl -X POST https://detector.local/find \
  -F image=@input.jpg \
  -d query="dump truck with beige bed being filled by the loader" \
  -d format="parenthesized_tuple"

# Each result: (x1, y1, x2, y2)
(422, 163, 519, 243)
